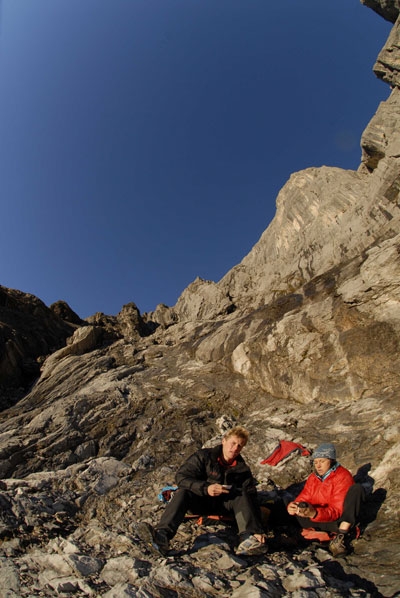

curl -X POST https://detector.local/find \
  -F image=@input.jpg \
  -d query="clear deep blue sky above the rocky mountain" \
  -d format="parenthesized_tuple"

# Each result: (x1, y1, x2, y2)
(0, 0, 391, 317)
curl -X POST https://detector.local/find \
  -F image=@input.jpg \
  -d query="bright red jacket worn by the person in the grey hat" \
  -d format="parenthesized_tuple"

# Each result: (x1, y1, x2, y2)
(296, 465, 354, 522)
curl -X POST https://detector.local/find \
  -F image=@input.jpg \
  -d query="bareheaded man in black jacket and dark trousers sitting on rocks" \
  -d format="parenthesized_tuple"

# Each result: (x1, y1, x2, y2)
(138, 426, 267, 555)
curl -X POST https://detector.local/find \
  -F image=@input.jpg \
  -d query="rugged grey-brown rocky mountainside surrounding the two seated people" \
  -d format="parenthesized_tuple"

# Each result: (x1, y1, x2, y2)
(0, 0, 400, 598)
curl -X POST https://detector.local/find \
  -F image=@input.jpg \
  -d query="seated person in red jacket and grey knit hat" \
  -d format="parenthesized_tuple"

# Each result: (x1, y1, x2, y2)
(287, 443, 364, 556)
